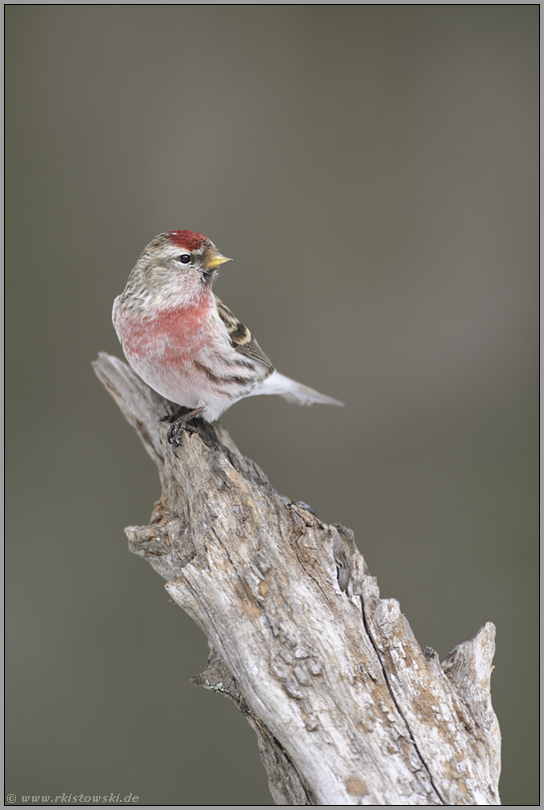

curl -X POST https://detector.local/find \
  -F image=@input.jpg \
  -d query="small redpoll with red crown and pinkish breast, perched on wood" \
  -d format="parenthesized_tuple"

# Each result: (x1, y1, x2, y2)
(113, 231, 343, 452)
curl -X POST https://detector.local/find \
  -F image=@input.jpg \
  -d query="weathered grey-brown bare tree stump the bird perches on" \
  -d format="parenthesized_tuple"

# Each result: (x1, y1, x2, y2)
(94, 354, 500, 805)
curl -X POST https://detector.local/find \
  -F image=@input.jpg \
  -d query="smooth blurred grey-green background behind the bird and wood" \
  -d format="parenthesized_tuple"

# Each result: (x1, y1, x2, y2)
(6, 5, 538, 805)
